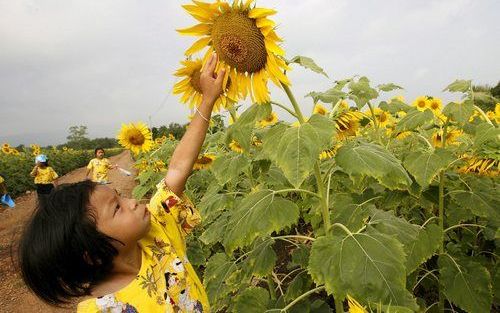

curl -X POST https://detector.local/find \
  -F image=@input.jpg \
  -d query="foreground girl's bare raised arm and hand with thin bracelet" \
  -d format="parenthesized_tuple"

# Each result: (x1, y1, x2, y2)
(165, 54, 225, 196)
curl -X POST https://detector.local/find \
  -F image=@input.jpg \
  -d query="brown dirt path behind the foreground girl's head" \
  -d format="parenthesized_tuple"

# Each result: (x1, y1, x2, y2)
(0, 151, 135, 313)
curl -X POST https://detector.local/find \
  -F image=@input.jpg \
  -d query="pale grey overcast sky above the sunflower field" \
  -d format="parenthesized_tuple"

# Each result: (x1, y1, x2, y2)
(0, 0, 500, 145)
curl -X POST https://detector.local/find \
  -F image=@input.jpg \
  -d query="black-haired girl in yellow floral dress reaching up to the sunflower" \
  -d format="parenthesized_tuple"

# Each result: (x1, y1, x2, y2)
(19, 55, 224, 313)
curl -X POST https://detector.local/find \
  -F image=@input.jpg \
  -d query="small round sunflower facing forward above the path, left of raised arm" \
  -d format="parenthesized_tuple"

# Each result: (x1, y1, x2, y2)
(116, 122, 153, 154)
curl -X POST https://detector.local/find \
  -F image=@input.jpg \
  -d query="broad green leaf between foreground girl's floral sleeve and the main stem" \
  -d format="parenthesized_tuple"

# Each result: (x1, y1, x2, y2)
(223, 190, 299, 252)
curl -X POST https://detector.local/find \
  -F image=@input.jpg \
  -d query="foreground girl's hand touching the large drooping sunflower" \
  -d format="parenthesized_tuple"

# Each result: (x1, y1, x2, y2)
(200, 53, 225, 104)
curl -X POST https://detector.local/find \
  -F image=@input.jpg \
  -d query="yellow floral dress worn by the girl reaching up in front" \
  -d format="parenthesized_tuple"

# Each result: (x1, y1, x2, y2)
(77, 180, 210, 313)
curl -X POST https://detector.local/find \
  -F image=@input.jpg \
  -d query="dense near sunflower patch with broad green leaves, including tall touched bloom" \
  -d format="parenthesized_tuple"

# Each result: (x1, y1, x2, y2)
(130, 0, 500, 313)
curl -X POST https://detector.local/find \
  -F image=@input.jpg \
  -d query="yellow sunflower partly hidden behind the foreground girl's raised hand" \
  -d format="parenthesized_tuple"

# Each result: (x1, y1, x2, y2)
(173, 59, 238, 111)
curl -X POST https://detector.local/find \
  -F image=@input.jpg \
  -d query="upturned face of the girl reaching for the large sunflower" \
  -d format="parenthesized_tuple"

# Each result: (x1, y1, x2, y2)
(90, 185, 151, 249)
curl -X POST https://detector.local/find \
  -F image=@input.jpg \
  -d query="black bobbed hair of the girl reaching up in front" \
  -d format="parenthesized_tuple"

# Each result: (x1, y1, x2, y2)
(19, 180, 118, 305)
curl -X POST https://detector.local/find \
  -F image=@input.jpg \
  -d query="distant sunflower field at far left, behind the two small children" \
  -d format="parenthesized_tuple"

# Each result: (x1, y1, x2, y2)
(0, 143, 123, 197)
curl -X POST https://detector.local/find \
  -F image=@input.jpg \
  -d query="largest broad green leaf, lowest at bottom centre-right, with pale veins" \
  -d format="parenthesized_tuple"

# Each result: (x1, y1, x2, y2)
(308, 229, 417, 309)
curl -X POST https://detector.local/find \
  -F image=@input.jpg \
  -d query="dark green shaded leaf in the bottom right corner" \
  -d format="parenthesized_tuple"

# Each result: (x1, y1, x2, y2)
(438, 254, 493, 313)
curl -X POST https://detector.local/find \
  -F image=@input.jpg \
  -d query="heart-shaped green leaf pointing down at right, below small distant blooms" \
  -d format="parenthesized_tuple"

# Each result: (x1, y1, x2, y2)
(403, 149, 454, 189)
